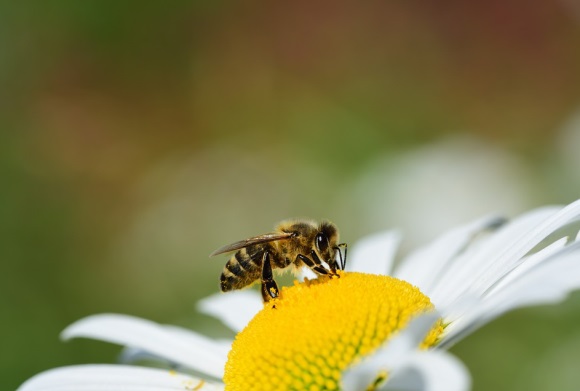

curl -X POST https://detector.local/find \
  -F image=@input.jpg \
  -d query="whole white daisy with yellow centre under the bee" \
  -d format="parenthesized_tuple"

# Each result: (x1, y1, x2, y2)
(19, 201, 580, 391)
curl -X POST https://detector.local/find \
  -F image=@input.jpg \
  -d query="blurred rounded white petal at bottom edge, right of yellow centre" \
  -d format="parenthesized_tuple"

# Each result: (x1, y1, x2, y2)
(379, 350, 471, 391)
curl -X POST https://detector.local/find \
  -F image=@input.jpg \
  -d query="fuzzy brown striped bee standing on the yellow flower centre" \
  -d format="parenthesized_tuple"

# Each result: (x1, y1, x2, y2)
(210, 220, 347, 302)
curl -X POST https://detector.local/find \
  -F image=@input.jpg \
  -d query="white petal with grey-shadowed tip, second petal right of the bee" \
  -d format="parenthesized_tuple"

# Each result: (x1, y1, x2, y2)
(394, 216, 503, 296)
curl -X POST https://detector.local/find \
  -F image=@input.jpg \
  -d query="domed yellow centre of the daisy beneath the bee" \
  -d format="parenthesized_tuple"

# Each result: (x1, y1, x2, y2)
(224, 272, 443, 391)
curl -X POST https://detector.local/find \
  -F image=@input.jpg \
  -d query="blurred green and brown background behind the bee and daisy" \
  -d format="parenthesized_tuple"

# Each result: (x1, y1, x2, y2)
(0, 0, 580, 390)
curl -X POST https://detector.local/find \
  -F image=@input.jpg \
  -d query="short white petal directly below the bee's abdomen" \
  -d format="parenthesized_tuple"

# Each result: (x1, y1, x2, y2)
(197, 289, 264, 332)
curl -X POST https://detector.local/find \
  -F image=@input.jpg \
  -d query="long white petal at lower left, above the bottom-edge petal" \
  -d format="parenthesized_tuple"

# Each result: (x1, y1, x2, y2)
(61, 314, 227, 378)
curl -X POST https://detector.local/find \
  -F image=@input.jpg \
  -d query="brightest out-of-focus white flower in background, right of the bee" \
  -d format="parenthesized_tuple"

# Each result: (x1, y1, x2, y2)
(335, 137, 536, 248)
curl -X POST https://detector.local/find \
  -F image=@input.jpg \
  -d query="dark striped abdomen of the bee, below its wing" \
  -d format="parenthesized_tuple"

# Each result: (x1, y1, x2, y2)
(220, 248, 263, 292)
